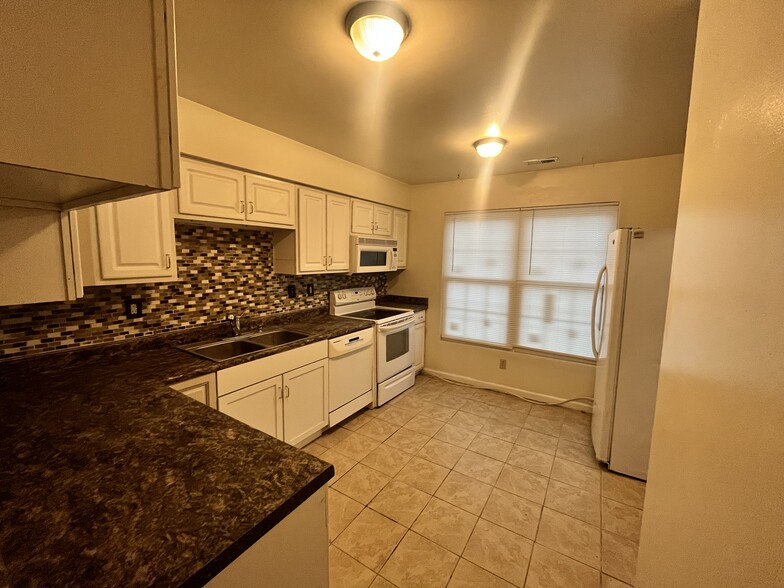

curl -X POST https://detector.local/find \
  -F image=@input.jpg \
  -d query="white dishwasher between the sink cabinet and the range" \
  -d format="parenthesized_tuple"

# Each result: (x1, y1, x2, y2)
(329, 327, 376, 427)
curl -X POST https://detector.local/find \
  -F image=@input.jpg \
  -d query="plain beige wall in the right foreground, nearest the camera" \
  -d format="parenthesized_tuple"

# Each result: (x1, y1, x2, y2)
(636, 0, 784, 588)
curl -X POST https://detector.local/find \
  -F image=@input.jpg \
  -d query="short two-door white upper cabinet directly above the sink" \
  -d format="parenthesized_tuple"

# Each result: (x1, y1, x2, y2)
(176, 158, 296, 229)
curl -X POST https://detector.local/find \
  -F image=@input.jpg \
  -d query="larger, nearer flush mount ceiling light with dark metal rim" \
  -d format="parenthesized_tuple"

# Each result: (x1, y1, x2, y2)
(346, 0, 411, 61)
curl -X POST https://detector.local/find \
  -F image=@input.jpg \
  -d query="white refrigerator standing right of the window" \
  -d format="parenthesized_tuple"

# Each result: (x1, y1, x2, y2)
(591, 229, 675, 480)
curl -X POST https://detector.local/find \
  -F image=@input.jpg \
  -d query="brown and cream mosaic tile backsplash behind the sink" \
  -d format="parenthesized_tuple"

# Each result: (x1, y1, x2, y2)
(0, 223, 387, 358)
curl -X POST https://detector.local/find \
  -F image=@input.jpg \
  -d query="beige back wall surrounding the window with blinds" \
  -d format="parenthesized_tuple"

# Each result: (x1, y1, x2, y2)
(390, 155, 682, 399)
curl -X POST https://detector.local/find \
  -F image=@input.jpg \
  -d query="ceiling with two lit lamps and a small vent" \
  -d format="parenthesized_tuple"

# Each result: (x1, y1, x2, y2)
(176, 0, 698, 184)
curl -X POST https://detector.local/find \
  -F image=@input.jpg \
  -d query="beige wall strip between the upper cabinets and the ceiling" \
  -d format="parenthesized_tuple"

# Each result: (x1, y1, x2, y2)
(179, 97, 410, 209)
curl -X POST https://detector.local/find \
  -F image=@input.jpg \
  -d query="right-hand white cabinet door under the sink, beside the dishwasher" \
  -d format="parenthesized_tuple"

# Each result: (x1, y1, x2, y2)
(283, 359, 329, 445)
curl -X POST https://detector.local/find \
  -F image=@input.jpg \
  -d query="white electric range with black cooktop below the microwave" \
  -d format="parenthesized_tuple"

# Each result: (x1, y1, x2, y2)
(329, 286, 415, 406)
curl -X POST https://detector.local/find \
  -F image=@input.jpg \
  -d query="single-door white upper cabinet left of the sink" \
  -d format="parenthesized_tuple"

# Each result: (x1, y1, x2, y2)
(76, 193, 177, 286)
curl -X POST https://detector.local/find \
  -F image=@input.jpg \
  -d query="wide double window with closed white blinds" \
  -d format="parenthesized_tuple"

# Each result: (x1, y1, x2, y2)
(442, 204, 618, 358)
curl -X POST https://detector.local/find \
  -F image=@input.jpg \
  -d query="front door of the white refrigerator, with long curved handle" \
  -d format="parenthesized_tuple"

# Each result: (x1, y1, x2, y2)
(591, 229, 630, 462)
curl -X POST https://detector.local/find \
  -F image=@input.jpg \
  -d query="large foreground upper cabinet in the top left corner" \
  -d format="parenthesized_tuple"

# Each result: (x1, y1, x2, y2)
(0, 0, 179, 210)
